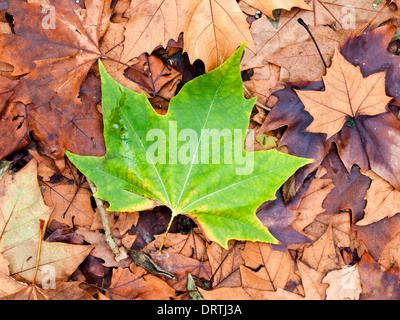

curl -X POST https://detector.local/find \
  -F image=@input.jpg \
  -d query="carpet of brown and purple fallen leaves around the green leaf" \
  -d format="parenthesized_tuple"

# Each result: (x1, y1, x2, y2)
(0, 0, 400, 300)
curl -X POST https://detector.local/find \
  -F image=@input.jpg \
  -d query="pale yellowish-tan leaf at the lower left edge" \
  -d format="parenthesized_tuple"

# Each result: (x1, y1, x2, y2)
(0, 160, 93, 283)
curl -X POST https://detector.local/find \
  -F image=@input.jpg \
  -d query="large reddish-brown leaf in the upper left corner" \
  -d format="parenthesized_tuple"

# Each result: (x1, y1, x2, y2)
(0, 0, 111, 167)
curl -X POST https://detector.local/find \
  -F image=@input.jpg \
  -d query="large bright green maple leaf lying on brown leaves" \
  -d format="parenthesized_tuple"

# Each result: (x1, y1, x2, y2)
(67, 45, 310, 247)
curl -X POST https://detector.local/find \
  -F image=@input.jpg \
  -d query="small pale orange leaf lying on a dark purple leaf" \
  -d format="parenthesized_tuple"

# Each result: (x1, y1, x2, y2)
(295, 50, 392, 139)
